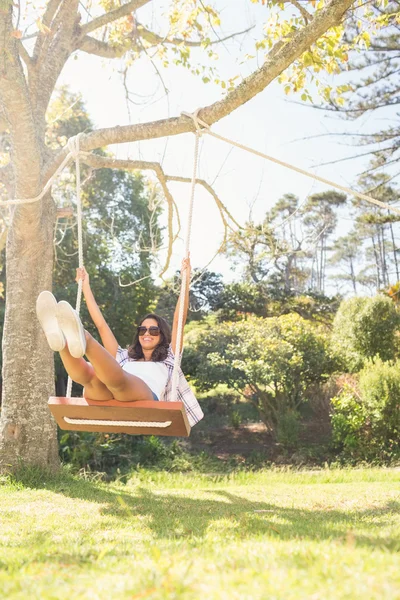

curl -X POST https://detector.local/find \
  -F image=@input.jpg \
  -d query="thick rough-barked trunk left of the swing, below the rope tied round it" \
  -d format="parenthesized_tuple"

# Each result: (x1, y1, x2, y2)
(0, 197, 59, 471)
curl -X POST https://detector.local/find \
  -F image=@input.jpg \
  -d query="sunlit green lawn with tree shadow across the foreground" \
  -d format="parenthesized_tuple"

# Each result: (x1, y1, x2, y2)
(0, 469, 400, 600)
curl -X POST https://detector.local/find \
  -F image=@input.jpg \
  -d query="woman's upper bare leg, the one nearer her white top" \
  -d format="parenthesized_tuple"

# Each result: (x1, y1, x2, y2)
(83, 331, 153, 402)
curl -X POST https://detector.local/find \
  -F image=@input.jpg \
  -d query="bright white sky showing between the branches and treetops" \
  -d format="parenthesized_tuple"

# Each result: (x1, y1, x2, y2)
(52, 0, 394, 290)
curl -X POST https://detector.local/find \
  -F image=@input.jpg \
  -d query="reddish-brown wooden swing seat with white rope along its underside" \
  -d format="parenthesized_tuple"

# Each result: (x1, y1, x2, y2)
(49, 396, 190, 437)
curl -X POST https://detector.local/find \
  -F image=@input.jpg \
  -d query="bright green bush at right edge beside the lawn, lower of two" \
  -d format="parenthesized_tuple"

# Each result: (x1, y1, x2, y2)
(332, 359, 400, 461)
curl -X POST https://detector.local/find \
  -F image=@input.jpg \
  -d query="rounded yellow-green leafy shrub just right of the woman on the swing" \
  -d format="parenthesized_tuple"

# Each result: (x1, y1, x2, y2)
(183, 314, 333, 429)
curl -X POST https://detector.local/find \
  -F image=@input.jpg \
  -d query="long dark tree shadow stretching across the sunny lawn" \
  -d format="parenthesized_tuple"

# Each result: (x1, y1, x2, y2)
(8, 473, 400, 552)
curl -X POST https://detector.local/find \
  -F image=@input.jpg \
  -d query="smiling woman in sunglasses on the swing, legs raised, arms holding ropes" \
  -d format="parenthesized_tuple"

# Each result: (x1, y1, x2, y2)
(36, 259, 203, 426)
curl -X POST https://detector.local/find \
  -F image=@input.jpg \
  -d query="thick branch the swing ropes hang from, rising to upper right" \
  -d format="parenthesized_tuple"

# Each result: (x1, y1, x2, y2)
(46, 0, 353, 178)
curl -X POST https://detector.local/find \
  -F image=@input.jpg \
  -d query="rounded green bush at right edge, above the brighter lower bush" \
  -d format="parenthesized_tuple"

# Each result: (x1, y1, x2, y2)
(332, 295, 400, 373)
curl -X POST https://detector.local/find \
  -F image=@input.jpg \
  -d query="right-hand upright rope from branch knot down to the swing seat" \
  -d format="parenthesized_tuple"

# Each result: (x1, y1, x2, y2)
(171, 111, 203, 398)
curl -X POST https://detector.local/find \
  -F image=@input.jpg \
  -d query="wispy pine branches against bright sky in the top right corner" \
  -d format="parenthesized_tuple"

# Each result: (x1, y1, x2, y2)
(326, 0, 400, 173)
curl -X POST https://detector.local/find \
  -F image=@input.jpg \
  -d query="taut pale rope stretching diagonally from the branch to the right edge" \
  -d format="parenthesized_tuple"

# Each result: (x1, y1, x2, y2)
(182, 109, 400, 215)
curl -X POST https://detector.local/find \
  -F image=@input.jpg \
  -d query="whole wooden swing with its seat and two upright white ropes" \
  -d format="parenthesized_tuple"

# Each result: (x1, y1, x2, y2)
(48, 129, 201, 437)
